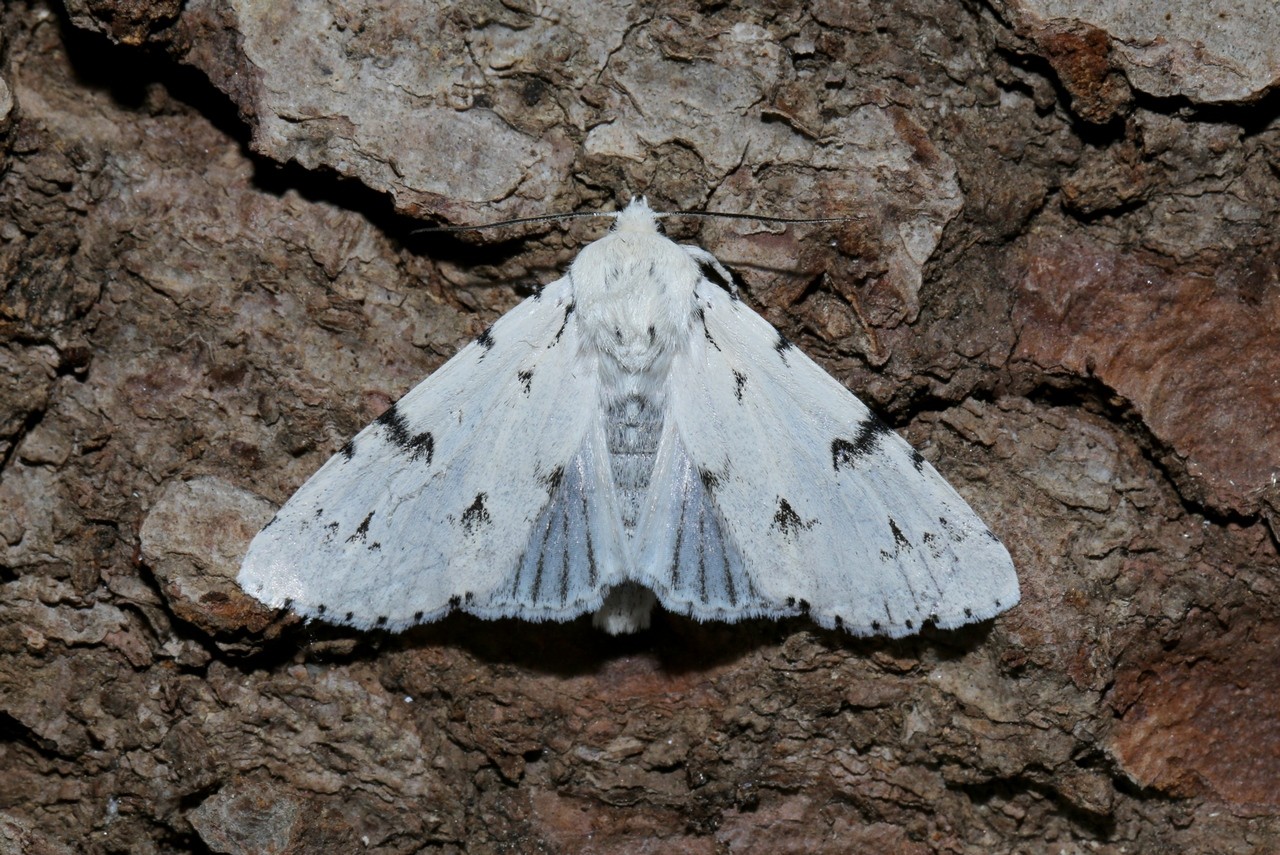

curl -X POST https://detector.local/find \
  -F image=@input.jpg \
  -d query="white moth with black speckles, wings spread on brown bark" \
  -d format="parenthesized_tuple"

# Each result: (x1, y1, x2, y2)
(239, 200, 1019, 636)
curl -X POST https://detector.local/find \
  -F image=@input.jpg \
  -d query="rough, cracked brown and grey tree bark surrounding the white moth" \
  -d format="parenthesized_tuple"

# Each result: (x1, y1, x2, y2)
(0, 0, 1280, 855)
